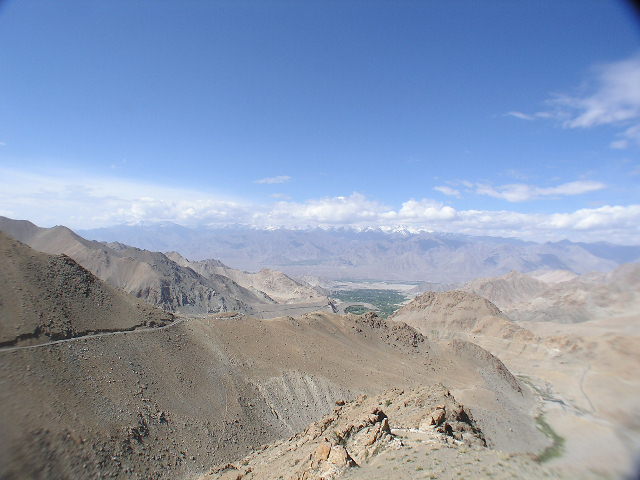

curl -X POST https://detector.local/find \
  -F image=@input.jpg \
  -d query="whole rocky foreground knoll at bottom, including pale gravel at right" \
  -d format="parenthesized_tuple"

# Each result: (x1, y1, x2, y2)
(198, 385, 568, 480)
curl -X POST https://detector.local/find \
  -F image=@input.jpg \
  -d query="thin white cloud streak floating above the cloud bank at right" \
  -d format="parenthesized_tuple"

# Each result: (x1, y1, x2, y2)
(475, 180, 606, 202)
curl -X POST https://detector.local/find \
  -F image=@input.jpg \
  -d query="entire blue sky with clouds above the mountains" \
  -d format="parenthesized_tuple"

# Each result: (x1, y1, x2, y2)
(0, 0, 640, 244)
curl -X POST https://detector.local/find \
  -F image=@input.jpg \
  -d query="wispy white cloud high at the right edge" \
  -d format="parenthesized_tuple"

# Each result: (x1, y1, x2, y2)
(505, 54, 640, 149)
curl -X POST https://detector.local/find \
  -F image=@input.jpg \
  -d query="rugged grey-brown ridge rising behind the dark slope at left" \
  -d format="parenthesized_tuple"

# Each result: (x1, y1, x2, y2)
(0, 217, 274, 313)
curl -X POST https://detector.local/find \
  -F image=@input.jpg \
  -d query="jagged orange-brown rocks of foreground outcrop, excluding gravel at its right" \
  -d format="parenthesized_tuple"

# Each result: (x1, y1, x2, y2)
(201, 385, 486, 480)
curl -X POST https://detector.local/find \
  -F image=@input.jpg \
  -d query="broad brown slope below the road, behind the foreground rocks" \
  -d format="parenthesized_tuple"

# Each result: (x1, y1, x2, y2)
(0, 314, 547, 480)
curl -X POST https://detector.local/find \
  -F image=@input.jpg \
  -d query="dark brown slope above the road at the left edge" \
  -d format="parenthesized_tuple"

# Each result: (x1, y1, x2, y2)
(0, 232, 173, 346)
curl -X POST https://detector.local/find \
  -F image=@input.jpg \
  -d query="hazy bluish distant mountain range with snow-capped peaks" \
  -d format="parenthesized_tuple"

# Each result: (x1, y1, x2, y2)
(80, 223, 640, 283)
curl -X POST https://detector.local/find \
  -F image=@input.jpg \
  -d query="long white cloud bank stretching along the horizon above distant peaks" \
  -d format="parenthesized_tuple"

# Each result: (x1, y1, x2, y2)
(0, 168, 640, 244)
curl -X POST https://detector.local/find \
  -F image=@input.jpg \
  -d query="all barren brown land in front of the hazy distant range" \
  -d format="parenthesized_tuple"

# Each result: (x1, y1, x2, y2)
(0, 218, 640, 480)
